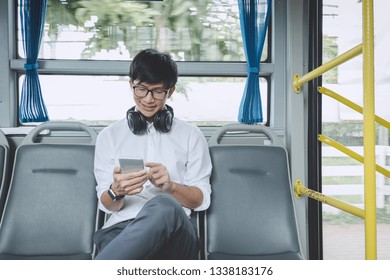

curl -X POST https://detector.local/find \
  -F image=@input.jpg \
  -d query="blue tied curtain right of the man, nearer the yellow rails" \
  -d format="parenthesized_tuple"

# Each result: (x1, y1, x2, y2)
(238, 0, 272, 124)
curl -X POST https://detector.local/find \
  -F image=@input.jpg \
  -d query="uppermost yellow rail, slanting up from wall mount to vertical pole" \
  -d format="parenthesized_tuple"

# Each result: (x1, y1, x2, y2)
(293, 44, 363, 93)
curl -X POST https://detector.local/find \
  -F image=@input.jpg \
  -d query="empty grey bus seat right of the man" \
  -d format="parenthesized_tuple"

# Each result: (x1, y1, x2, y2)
(205, 124, 303, 260)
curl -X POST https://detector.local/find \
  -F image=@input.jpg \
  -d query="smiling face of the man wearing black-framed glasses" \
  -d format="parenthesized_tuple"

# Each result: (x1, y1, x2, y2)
(130, 81, 175, 122)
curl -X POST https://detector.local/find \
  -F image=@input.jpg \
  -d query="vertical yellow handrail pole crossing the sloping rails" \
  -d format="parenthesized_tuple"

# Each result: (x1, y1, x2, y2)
(363, 0, 377, 260)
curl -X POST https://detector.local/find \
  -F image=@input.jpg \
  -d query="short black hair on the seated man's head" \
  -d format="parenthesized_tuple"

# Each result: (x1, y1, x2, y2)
(129, 49, 178, 89)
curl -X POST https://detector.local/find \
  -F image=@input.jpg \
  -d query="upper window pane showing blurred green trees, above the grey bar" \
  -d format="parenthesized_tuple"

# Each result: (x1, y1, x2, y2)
(19, 0, 267, 61)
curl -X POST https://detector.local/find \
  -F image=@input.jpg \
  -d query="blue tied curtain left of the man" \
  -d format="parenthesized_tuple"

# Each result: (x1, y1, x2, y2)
(19, 0, 49, 122)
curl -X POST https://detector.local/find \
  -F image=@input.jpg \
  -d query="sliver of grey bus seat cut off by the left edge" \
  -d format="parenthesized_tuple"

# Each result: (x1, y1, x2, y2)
(0, 130, 10, 223)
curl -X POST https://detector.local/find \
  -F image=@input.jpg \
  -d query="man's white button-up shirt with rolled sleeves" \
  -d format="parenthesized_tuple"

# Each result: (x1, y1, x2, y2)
(94, 118, 212, 228)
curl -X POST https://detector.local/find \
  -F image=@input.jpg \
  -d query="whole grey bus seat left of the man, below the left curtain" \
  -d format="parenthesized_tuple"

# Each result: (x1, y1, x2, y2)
(0, 122, 98, 260)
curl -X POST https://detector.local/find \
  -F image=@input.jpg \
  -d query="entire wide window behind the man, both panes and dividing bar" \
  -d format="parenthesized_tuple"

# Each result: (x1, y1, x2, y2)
(18, 0, 273, 125)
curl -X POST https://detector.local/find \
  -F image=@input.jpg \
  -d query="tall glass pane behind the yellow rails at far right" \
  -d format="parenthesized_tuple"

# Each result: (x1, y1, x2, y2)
(322, 0, 390, 259)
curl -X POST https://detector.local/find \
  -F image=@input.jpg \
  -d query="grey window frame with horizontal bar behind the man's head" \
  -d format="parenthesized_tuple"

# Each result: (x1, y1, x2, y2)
(0, 0, 286, 127)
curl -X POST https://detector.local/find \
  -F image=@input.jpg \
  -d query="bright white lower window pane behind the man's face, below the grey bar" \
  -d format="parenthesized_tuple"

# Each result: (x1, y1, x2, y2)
(19, 75, 268, 126)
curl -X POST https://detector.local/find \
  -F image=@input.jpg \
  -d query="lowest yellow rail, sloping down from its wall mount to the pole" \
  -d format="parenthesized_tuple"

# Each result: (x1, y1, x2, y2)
(294, 180, 364, 219)
